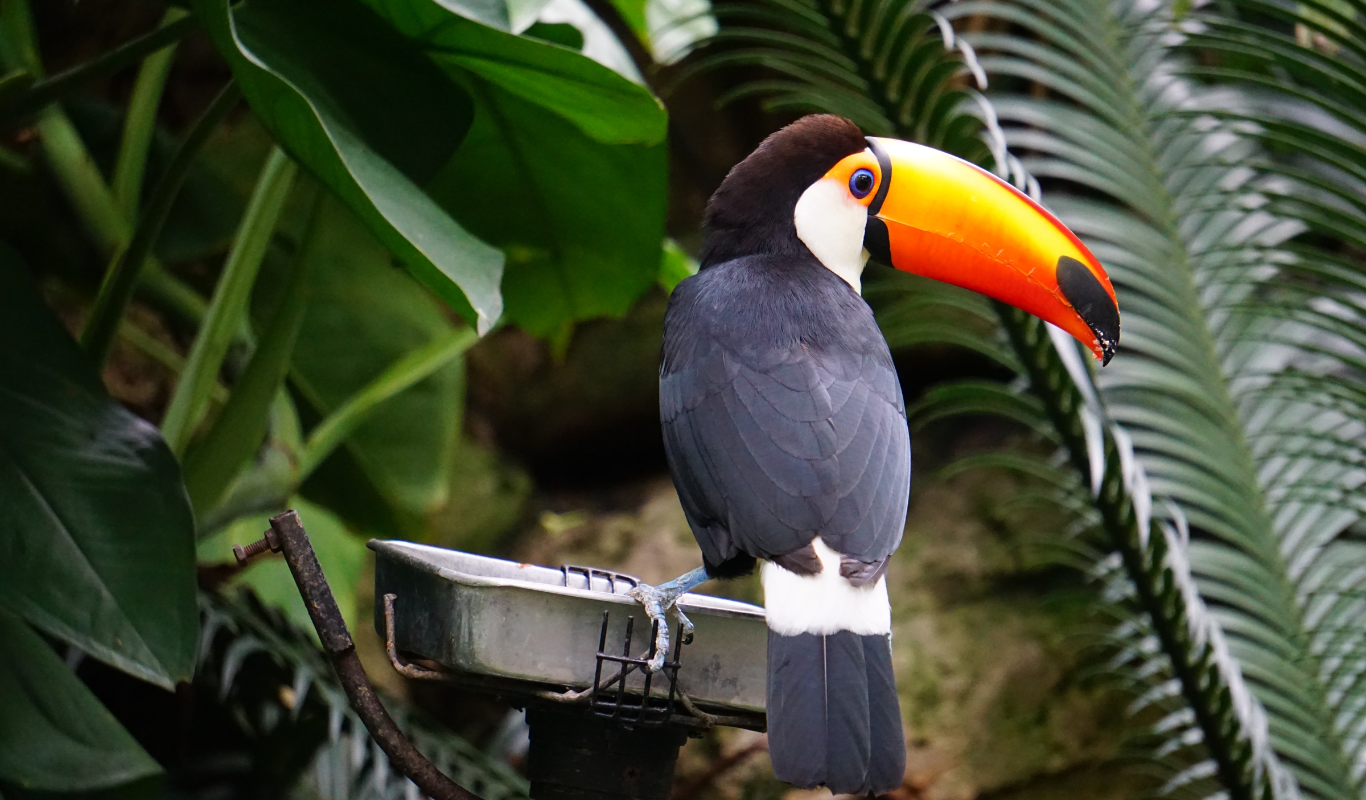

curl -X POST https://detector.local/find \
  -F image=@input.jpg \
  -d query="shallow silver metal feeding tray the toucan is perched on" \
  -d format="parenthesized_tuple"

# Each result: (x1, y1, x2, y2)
(370, 541, 768, 728)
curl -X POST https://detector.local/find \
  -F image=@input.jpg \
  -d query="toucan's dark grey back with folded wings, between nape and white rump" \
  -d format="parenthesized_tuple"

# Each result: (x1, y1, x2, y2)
(660, 254, 911, 578)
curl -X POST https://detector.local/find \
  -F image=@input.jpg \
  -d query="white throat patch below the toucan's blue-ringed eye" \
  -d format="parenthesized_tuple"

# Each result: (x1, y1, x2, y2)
(792, 177, 867, 295)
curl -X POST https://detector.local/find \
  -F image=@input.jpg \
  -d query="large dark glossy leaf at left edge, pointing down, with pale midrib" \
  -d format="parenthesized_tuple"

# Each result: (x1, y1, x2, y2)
(0, 246, 199, 688)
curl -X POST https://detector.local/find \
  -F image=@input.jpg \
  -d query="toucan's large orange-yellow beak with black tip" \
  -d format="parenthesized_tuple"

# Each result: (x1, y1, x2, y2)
(836, 137, 1119, 363)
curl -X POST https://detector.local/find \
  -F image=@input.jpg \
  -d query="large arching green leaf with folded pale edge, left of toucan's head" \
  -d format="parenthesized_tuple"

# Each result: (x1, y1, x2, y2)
(197, 0, 665, 334)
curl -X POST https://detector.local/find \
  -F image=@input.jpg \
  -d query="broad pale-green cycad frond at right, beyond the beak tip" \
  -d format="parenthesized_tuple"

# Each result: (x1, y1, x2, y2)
(953, 0, 1366, 797)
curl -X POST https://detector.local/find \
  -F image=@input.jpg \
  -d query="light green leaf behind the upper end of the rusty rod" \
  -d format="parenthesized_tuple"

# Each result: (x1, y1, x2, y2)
(199, 497, 366, 635)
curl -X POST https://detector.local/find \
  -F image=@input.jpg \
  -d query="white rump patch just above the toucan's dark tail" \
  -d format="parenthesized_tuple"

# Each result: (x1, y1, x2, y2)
(759, 535, 892, 636)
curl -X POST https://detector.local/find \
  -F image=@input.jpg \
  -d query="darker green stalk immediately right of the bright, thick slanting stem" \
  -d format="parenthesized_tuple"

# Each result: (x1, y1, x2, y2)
(184, 187, 326, 519)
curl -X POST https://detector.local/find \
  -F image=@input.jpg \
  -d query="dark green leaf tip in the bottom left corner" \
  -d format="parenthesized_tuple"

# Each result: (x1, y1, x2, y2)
(0, 609, 161, 792)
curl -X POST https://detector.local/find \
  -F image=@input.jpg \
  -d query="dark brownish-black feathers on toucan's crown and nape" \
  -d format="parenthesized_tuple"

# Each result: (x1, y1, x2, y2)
(702, 113, 867, 268)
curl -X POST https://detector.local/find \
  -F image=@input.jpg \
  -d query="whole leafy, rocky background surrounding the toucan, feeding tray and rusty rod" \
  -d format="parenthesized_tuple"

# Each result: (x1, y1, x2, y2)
(0, 0, 1366, 800)
